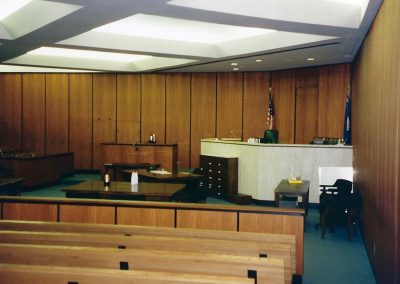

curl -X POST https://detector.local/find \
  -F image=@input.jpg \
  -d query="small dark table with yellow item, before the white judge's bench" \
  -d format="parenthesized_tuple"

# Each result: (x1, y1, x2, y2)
(275, 179, 310, 215)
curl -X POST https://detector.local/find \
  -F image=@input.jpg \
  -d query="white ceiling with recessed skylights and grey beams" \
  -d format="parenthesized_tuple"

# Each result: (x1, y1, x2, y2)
(0, 0, 382, 72)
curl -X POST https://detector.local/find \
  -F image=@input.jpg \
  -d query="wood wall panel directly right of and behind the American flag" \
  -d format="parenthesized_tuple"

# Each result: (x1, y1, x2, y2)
(271, 70, 296, 144)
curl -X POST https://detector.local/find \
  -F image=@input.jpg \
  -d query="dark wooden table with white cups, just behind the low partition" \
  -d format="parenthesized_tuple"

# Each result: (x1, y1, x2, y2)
(62, 181, 185, 201)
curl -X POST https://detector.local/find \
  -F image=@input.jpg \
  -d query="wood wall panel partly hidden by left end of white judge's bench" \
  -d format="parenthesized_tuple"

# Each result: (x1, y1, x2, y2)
(190, 73, 217, 168)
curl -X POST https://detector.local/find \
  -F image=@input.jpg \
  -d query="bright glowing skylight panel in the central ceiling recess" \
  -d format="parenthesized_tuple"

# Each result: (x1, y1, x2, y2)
(93, 14, 274, 44)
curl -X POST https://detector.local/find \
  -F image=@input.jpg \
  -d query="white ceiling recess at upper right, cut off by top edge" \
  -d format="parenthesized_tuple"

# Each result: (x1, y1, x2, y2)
(168, 0, 369, 28)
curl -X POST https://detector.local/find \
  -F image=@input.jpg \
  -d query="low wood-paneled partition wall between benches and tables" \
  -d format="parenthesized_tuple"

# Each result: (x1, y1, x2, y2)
(0, 196, 304, 276)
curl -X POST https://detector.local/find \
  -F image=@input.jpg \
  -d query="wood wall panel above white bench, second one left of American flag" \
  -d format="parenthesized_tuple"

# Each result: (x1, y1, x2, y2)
(217, 73, 243, 139)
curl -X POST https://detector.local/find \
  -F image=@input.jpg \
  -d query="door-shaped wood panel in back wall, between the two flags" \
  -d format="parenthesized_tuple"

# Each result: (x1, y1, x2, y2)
(294, 87, 318, 144)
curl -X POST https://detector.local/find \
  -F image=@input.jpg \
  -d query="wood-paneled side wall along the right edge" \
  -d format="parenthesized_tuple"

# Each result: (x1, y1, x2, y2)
(352, 0, 400, 284)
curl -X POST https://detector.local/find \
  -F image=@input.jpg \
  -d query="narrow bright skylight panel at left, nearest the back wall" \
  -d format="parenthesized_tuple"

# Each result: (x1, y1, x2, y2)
(27, 47, 152, 62)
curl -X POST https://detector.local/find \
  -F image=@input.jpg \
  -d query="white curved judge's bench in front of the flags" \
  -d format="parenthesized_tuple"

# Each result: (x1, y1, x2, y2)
(201, 138, 353, 203)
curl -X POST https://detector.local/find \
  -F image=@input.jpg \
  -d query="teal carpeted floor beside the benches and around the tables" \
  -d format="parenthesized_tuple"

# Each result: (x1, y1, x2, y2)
(22, 174, 376, 284)
